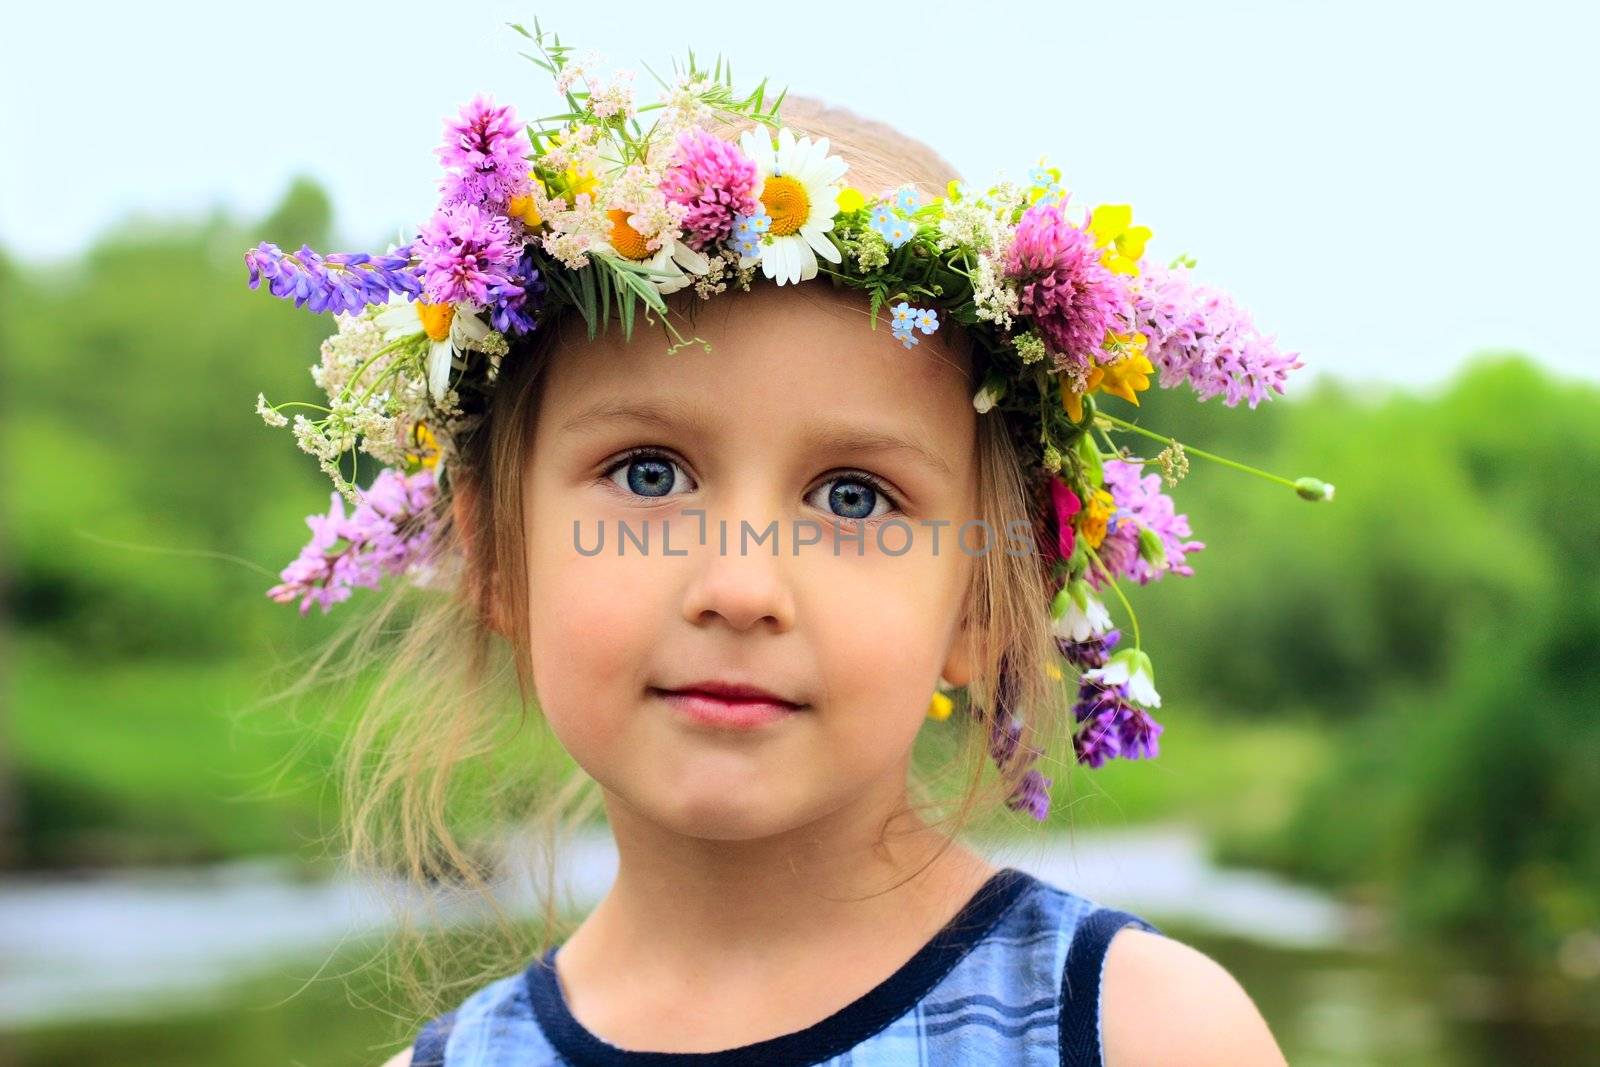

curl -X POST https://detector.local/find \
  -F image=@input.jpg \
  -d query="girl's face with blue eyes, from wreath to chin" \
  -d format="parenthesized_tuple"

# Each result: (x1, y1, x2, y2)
(523, 283, 981, 840)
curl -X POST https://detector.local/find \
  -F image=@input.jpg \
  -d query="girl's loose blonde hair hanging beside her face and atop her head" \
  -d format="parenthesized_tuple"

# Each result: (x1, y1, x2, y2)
(259, 96, 1069, 1043)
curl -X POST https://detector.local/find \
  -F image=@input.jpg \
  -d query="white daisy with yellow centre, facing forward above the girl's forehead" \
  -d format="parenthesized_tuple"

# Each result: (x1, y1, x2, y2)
(739, 126, 850, 285)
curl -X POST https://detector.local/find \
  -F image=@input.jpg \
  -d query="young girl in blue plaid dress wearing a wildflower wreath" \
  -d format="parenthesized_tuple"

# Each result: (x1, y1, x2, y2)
(250, 32, 1304, 1067)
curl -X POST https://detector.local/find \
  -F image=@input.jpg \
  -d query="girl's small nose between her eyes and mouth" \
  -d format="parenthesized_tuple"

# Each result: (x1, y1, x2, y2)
(683, 509, 795, 632)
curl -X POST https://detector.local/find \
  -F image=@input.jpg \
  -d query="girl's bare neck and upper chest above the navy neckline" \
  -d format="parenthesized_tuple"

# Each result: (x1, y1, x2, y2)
(557, 780, 997, 1051)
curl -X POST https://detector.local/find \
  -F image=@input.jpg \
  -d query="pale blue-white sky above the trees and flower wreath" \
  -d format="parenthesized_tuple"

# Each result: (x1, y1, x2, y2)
(0, 0, 1600, 384)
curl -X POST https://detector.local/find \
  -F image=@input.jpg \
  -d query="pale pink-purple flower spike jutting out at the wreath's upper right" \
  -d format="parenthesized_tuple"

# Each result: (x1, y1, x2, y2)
(1134, 262, 1302, 408)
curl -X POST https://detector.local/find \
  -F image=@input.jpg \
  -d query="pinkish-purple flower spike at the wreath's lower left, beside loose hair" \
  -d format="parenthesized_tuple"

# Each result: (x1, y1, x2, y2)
(267, 467, 437, 616)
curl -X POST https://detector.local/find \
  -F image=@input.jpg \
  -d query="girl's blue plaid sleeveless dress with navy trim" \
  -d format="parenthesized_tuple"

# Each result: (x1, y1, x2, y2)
(411, 867, 1162, 1067)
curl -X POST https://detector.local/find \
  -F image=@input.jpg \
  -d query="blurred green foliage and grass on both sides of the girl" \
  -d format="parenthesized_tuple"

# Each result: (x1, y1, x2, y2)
(0, 182, 1600, 955)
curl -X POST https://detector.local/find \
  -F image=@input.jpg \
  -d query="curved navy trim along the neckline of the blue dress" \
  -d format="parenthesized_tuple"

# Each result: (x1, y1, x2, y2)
(526, 867, 1037, 1067)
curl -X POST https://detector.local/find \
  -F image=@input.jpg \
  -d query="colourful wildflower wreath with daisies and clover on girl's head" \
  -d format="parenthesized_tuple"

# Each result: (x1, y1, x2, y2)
(245, 22, 1333, 819)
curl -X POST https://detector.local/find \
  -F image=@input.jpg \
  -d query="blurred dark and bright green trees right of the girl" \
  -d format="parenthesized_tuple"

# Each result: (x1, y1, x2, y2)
(1139, 355, 1600, 960)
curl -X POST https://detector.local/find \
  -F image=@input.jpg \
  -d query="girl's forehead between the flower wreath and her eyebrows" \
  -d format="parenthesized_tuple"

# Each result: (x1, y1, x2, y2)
(539, 280, 976, 460)
